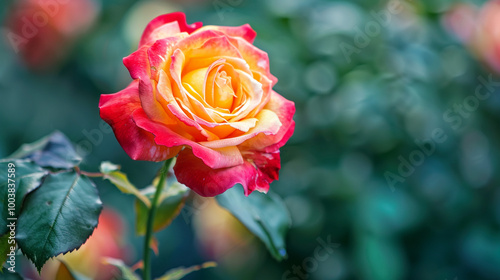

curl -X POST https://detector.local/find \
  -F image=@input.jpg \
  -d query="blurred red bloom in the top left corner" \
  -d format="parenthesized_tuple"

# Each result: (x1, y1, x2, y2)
(6, 0, 98, 70)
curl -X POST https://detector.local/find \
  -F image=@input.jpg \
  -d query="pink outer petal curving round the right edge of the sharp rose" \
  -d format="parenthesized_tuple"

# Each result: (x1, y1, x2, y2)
(238, 91, 295, 152)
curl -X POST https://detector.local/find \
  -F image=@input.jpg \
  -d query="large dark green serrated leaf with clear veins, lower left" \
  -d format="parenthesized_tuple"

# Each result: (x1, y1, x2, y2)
(16, 171, 102, 270)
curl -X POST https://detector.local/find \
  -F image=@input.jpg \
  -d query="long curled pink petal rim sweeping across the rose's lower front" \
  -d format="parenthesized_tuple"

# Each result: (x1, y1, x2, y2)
(132, 109, 243, 168)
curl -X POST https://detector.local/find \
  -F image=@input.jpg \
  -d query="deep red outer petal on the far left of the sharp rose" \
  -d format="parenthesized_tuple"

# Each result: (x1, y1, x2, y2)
(99, 81, 180, 161)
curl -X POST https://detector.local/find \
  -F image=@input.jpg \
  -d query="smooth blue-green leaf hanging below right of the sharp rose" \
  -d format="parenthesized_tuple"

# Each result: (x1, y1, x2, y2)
(217, 186, 291, 260)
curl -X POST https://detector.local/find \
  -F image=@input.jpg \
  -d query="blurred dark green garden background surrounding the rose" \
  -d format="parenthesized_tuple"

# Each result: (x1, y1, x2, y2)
(0, 0, 500, 280)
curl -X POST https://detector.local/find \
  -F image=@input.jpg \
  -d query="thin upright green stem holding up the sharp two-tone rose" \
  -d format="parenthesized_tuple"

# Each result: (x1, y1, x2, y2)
(143, 158, 173, 280)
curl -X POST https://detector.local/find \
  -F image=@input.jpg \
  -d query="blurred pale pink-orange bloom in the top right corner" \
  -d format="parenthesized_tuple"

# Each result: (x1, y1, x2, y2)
(445, 0, 500, 73)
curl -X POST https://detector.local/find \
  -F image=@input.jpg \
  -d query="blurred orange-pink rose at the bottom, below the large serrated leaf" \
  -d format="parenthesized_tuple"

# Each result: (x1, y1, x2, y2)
(27, 208, 128, 280)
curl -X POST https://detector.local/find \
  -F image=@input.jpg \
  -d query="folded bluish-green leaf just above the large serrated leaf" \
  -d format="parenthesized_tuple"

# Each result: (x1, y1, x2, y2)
(9, 131, 82, 168)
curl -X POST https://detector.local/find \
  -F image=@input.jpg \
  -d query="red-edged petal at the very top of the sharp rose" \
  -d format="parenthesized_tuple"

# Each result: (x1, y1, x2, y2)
(139, 12, 203, 47)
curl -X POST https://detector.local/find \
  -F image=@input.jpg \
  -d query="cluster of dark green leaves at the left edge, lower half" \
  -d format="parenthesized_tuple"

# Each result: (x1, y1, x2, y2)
(0, 132, 102, 271)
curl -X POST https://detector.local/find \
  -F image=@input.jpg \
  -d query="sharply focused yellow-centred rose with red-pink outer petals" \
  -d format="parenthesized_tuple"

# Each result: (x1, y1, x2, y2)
(99, 13, 295, 196)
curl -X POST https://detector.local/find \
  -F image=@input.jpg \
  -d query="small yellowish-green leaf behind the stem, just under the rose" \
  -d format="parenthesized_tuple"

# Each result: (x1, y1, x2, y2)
(135, 182, 189, 235)
